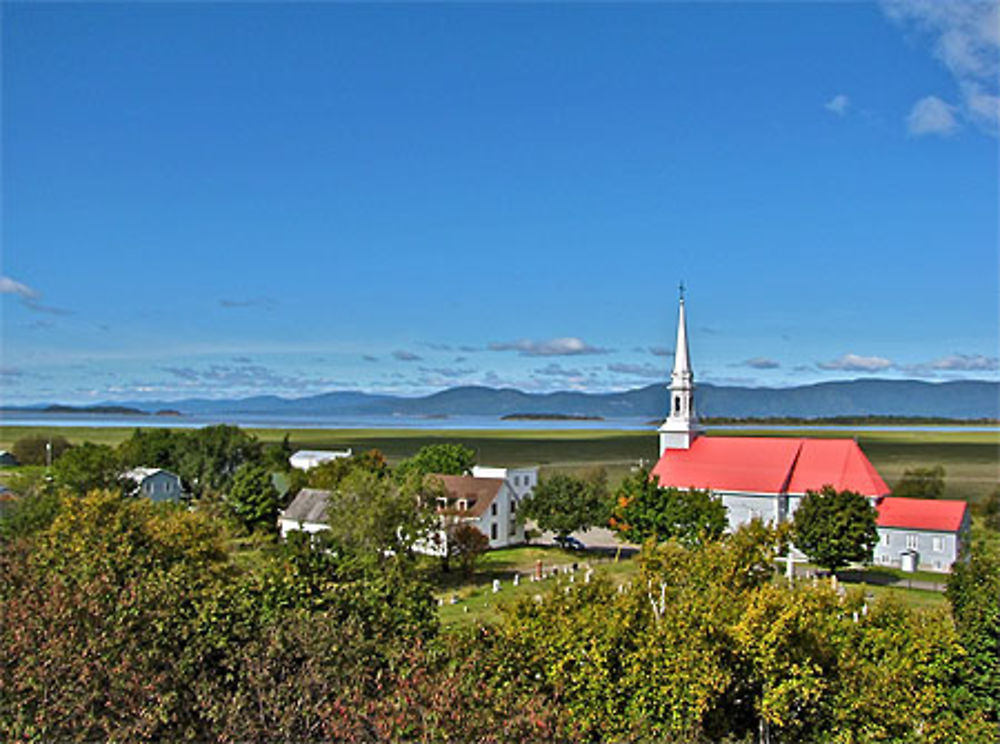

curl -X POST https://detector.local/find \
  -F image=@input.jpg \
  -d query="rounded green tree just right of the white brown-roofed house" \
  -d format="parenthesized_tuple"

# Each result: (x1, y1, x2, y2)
(517, 470, 610, 537)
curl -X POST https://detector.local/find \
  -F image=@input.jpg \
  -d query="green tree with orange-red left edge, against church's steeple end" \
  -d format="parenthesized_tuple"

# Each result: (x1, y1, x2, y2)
(611, 468, 726, 546)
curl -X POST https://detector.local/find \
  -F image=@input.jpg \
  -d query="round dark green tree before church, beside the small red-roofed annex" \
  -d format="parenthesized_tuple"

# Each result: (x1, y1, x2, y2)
(792, 485, 878, 571)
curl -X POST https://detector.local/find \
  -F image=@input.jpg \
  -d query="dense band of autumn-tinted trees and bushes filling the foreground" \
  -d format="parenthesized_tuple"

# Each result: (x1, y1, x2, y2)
(0, 492, 998, 744)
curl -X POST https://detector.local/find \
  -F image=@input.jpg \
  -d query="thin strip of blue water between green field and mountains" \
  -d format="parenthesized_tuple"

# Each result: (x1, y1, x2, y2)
(0, 411, 1000, 433)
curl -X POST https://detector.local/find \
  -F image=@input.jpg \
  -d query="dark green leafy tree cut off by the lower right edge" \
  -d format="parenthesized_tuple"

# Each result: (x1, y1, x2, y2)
(946, 540, 1000, 722)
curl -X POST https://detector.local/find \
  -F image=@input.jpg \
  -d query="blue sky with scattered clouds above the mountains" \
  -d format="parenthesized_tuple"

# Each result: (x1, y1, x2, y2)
(0, 0, 1000, 405)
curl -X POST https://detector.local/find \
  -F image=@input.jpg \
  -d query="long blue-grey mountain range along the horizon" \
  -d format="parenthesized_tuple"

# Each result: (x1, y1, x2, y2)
(8, 379, 1000, 419)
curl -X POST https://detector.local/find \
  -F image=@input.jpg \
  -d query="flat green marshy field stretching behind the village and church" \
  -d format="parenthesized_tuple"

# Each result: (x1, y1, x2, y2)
(0, 426, 1000, 501)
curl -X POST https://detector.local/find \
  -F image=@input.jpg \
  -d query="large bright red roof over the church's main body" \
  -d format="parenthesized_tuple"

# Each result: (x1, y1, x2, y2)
(652, 437, 889, 496)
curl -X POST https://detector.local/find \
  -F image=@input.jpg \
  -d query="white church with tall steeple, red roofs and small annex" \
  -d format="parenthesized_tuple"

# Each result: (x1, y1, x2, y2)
(652, 290, 969, 571)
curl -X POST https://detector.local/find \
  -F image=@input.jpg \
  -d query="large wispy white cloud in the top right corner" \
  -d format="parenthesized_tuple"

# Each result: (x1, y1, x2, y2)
(882, 0, 1000, 134)
